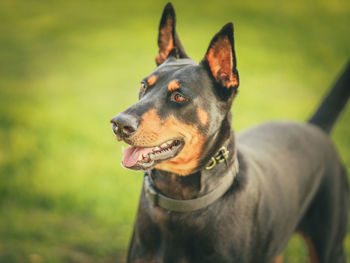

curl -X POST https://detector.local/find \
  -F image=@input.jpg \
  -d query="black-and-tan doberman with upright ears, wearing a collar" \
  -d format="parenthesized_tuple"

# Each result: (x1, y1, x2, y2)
(111, 3, 350, 263)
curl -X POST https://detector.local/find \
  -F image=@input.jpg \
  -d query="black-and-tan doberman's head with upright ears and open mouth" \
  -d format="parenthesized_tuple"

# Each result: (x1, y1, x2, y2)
(111, 3, 239, 175)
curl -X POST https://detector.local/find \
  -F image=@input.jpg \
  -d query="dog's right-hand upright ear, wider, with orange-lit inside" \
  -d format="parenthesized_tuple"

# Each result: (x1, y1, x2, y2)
(201, 23, 239, 92)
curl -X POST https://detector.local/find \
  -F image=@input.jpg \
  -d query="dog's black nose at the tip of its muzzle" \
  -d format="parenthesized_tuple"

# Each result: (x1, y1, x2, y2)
(111, 113, 139, 137)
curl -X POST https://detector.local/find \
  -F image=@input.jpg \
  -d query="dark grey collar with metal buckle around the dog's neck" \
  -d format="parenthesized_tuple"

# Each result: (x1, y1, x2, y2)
(144, 147, 239, 212)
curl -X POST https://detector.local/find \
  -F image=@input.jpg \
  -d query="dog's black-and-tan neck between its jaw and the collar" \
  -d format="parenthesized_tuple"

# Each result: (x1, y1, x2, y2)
(150, 121, 237, 200)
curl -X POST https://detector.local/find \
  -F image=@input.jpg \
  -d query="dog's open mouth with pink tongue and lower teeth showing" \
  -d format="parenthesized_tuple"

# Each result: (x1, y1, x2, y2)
(122, 139, 185, 170)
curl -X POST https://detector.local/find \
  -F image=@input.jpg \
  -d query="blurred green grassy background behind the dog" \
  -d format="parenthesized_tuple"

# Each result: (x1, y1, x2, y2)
(0, 0, 350, 263)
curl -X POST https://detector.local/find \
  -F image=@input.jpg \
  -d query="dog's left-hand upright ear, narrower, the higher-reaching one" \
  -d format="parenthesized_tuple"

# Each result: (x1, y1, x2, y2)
(156, 3, 188, 66)
